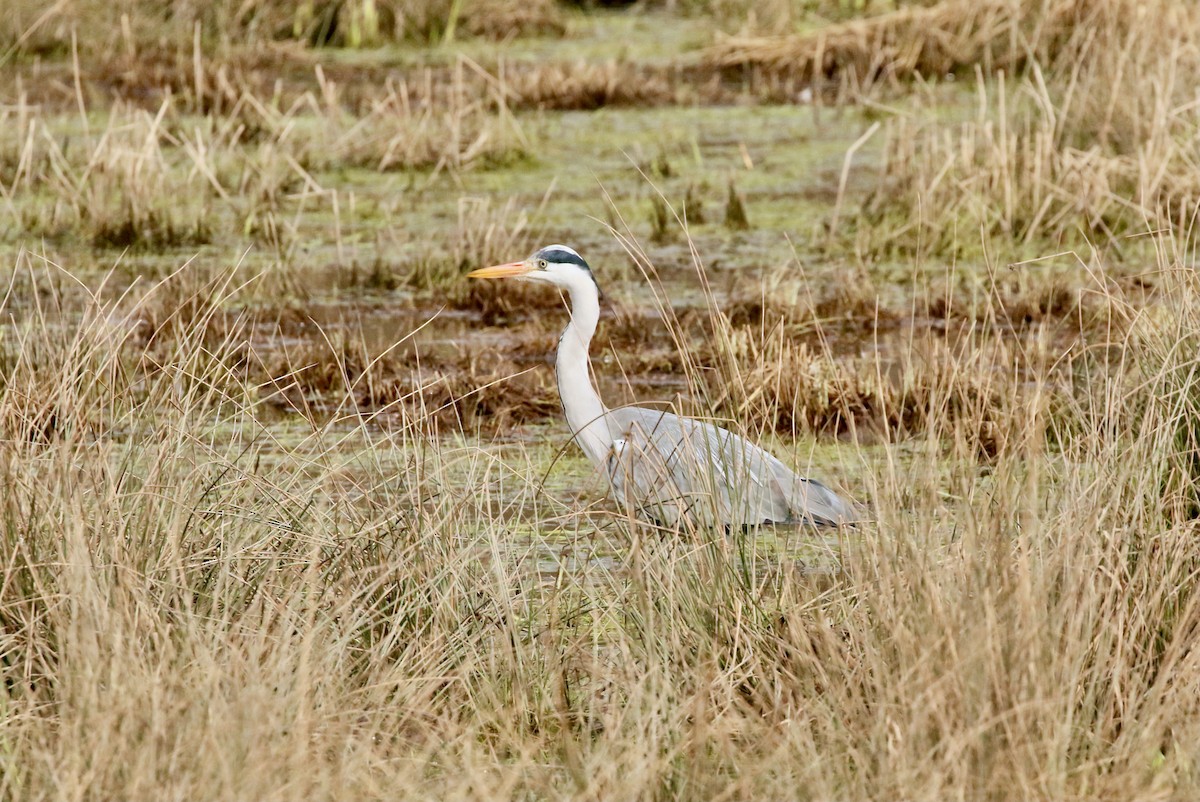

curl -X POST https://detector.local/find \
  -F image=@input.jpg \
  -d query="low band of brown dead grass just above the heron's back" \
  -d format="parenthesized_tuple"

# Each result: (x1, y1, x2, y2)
(707, 319, 1072, 460)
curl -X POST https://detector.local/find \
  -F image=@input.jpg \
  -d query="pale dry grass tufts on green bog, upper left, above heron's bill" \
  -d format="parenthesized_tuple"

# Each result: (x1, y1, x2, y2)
(0, 57, 528, 252)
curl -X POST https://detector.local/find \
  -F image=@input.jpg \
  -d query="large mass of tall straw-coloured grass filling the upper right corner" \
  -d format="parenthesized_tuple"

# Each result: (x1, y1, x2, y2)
(840, 0, 1200, 258)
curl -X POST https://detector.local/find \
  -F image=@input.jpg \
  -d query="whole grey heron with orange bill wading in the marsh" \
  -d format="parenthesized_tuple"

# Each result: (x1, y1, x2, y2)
(468, 245, 857, 528)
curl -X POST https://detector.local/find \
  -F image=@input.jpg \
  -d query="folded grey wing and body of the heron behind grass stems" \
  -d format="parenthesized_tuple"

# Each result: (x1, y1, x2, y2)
(607, 407, 854, 526)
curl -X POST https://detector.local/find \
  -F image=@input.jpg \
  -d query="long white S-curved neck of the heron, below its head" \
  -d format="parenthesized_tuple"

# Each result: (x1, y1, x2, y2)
(554, 287, 612, 465)
